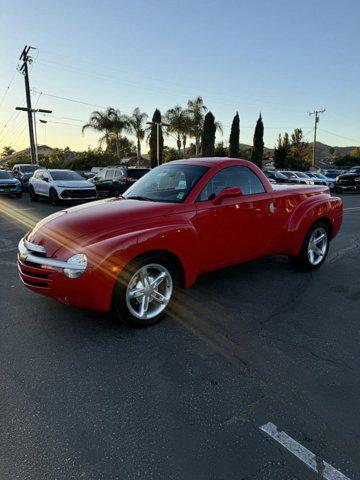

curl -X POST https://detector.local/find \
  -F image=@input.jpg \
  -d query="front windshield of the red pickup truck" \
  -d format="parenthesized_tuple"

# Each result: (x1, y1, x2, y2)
(124, 164, 209, 203)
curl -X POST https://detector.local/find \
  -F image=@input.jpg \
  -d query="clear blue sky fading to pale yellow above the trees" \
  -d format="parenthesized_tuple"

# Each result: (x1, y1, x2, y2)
(0, 0, 360, 149)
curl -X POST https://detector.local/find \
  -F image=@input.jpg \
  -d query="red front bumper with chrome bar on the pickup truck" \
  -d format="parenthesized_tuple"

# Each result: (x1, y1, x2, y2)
(17, 239, 115, 312)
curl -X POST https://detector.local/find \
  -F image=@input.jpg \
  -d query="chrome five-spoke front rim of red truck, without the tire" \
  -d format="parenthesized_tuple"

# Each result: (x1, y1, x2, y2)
(126, 263, 173, 320)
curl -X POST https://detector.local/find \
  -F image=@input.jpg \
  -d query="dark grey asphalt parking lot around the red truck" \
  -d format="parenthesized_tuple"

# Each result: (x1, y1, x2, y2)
(0, 194, 360, 480)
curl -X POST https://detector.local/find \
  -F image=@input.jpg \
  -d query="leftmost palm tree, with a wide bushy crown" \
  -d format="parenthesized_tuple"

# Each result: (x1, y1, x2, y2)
(82, 107, 130, 159)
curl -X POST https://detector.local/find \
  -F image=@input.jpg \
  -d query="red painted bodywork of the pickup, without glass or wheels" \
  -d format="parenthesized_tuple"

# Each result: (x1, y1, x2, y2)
(18, 158, 342, 311)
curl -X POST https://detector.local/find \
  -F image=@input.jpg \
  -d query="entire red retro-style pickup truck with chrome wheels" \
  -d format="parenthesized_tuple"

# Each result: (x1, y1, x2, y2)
(18, 158, 342, 327)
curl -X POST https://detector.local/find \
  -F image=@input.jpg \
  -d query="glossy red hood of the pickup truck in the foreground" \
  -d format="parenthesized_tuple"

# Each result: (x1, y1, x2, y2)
(26, 198, 180, 257)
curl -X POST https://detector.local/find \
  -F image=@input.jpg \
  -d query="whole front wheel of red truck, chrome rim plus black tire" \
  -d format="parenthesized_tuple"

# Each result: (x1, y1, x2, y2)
(113, 256, 178, 328)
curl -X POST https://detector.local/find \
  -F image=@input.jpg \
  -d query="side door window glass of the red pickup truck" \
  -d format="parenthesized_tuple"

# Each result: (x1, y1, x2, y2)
(198, 166, 265, 202)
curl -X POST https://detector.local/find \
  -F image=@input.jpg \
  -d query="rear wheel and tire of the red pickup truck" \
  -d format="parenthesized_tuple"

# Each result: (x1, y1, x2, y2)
(289, 221, 330, 271)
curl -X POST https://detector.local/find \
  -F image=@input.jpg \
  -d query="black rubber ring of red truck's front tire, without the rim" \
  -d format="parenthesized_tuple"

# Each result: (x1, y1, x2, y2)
(112, 255, 179, 328)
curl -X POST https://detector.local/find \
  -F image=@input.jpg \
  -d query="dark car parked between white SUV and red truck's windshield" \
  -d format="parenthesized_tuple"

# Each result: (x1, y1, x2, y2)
(90, 167, 149, 197)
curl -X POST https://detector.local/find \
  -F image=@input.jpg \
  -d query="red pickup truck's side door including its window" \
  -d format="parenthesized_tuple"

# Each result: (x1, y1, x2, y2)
(194, 166, 274, 271)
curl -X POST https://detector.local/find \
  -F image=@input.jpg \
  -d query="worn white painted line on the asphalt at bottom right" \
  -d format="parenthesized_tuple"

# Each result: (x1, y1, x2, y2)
(260, 422, 350, 480)
